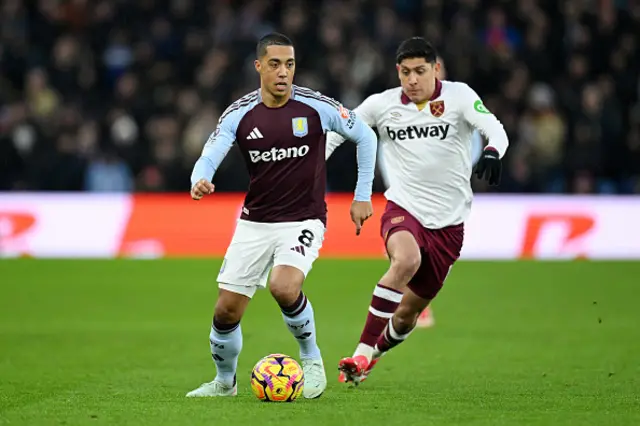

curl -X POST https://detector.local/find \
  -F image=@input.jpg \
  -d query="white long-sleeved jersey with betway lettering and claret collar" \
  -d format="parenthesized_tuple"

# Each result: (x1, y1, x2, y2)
(327, 81, 509, 229)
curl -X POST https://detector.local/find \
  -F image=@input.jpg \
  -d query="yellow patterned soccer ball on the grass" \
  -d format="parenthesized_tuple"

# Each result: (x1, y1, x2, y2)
(251, 354, 304, 402)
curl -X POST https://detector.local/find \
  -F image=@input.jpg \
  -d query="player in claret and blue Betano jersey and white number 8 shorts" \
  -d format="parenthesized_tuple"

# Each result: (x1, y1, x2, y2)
(187, 34, 377, 398)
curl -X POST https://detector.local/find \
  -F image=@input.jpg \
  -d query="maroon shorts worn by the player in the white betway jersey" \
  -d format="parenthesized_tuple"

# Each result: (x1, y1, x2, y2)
(380, 201, 464, 299)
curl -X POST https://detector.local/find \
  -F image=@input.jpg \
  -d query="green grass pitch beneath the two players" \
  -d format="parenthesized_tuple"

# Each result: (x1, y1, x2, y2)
(0, 260, 640, 426)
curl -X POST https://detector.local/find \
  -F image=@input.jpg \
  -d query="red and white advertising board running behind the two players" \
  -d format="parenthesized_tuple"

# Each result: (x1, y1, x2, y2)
(0, 193, 640, 260)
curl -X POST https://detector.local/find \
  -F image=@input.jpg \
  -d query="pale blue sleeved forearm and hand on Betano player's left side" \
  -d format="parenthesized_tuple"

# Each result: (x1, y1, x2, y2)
(191, 112, 236, 200)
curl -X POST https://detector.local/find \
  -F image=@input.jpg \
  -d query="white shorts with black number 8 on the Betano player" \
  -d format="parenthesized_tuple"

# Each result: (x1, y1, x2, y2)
(218, 219, 325, 297)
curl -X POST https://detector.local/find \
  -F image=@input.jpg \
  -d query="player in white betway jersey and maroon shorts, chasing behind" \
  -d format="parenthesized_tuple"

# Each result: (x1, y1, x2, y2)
(327, 37, 509, 384)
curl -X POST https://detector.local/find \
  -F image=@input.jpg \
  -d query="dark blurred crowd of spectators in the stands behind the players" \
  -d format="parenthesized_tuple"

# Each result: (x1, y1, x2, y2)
(0, 0, 640, 194)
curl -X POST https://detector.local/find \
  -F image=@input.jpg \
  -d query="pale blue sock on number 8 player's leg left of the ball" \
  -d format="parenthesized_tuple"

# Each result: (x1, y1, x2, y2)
(209, 324, 242, 386)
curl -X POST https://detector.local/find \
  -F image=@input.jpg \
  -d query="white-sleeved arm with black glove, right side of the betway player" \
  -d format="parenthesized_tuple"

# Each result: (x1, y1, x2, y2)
(460, 83, 509, 185)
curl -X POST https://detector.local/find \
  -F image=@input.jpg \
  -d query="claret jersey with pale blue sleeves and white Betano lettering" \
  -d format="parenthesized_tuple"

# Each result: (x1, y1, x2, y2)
(192, 86, 377, 222)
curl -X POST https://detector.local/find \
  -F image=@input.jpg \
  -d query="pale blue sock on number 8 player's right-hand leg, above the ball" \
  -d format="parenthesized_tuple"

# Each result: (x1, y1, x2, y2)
(282, 293, 321, 359)
